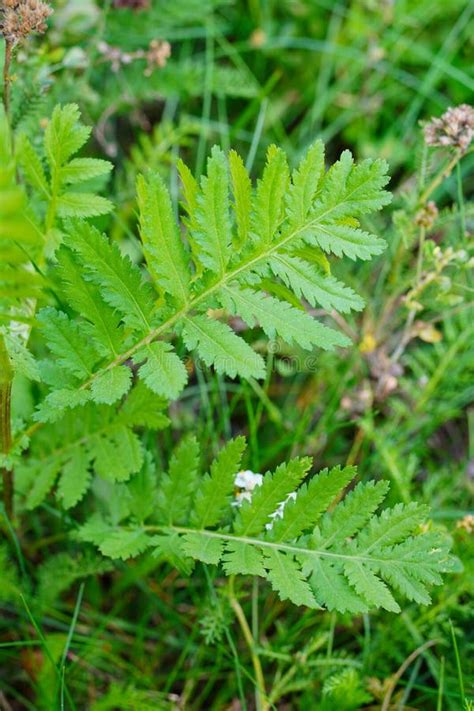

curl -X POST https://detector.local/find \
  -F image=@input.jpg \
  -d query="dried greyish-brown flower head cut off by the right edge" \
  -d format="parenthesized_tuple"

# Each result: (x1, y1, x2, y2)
(424, 104, 474, 153)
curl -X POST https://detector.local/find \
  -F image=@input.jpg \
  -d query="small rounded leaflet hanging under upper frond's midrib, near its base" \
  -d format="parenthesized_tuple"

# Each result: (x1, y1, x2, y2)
(133, 341, 188, 400)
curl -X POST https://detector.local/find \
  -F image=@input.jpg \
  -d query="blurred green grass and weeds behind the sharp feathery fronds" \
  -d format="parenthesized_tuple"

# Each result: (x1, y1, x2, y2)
(0, 0, 474, 711)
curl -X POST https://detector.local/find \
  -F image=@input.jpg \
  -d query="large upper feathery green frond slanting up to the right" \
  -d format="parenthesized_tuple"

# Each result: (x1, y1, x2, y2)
(32, 131, 389, 421)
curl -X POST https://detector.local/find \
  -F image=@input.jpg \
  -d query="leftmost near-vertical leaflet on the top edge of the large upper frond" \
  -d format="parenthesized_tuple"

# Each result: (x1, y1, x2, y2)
(137, 173, 191, 305)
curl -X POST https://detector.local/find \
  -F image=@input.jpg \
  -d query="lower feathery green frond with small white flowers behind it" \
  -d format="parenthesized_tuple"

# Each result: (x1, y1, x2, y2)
(79, 438, 455, 613)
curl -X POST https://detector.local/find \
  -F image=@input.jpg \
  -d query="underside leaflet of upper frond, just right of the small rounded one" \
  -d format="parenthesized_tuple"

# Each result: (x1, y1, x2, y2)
(183, 316, 265, 378)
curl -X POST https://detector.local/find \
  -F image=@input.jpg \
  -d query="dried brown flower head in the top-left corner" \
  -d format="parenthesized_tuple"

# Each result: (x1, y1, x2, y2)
(0, 0, 53, 45)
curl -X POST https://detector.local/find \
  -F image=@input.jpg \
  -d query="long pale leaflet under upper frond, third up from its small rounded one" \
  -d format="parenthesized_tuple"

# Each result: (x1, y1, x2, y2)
(218, 286, 350, 350)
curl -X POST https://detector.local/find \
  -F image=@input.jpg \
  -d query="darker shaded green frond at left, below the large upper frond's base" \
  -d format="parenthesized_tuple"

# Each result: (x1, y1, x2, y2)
(17, 386, 169, 509)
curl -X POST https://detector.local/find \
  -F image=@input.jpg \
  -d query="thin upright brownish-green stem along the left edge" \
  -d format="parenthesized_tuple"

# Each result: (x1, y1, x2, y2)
(0, 335, 13, 520)
